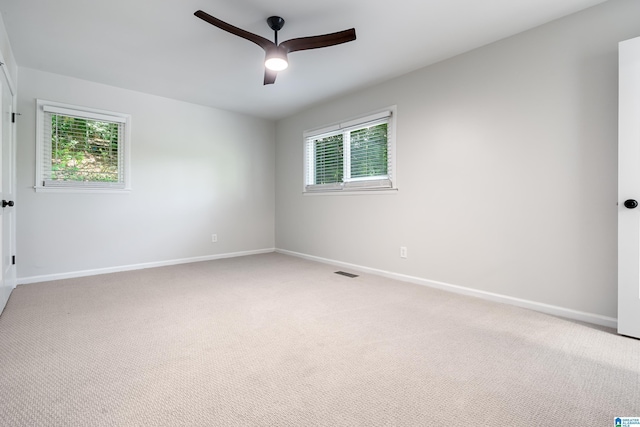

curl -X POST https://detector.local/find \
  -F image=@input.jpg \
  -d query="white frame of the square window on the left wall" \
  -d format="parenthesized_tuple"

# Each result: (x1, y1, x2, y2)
(34, 99, 131, 193)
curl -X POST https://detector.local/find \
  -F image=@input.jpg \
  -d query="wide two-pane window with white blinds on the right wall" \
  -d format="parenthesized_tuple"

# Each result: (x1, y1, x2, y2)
(304, 109, 395, 192)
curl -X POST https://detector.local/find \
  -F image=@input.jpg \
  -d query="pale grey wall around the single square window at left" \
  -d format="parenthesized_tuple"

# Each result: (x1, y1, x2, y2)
(16, 68, 275, 282)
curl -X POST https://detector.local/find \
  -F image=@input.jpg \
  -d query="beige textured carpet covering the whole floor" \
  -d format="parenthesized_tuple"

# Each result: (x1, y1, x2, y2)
(0, 254, 640, 427)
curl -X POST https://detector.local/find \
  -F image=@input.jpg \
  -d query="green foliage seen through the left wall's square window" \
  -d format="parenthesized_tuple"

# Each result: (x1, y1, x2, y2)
(51, 114, 120, 182)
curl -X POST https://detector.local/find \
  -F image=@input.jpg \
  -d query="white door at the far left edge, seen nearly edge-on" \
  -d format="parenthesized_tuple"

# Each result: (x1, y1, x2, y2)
(0, 67, 16, 312)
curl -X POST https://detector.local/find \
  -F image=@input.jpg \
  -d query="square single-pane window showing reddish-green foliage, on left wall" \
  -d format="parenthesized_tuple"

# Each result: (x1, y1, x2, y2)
(36, 100, 131, 192)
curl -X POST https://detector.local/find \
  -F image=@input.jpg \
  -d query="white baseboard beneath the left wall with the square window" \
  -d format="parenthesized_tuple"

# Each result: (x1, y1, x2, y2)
(17, 248, 275, 285)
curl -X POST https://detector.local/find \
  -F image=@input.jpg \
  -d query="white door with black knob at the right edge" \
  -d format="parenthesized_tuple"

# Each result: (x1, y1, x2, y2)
(618, 37, 640, 338)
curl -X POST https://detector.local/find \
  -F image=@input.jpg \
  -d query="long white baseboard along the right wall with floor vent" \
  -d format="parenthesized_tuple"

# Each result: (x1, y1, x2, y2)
(275, 249, 618, 329)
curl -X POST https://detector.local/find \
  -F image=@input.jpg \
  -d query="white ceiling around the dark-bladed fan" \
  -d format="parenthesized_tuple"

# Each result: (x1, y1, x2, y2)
(0, 0, 604, 119)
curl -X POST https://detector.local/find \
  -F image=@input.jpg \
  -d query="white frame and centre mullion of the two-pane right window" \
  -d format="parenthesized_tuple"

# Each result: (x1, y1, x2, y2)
(302, 105, 398, 196)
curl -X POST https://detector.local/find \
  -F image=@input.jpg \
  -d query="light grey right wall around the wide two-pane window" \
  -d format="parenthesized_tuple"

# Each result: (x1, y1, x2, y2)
(276, 0, 640, 317)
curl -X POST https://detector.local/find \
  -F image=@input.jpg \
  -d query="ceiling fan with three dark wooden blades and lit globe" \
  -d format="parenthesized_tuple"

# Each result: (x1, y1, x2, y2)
(194, 10, 356, 85)
